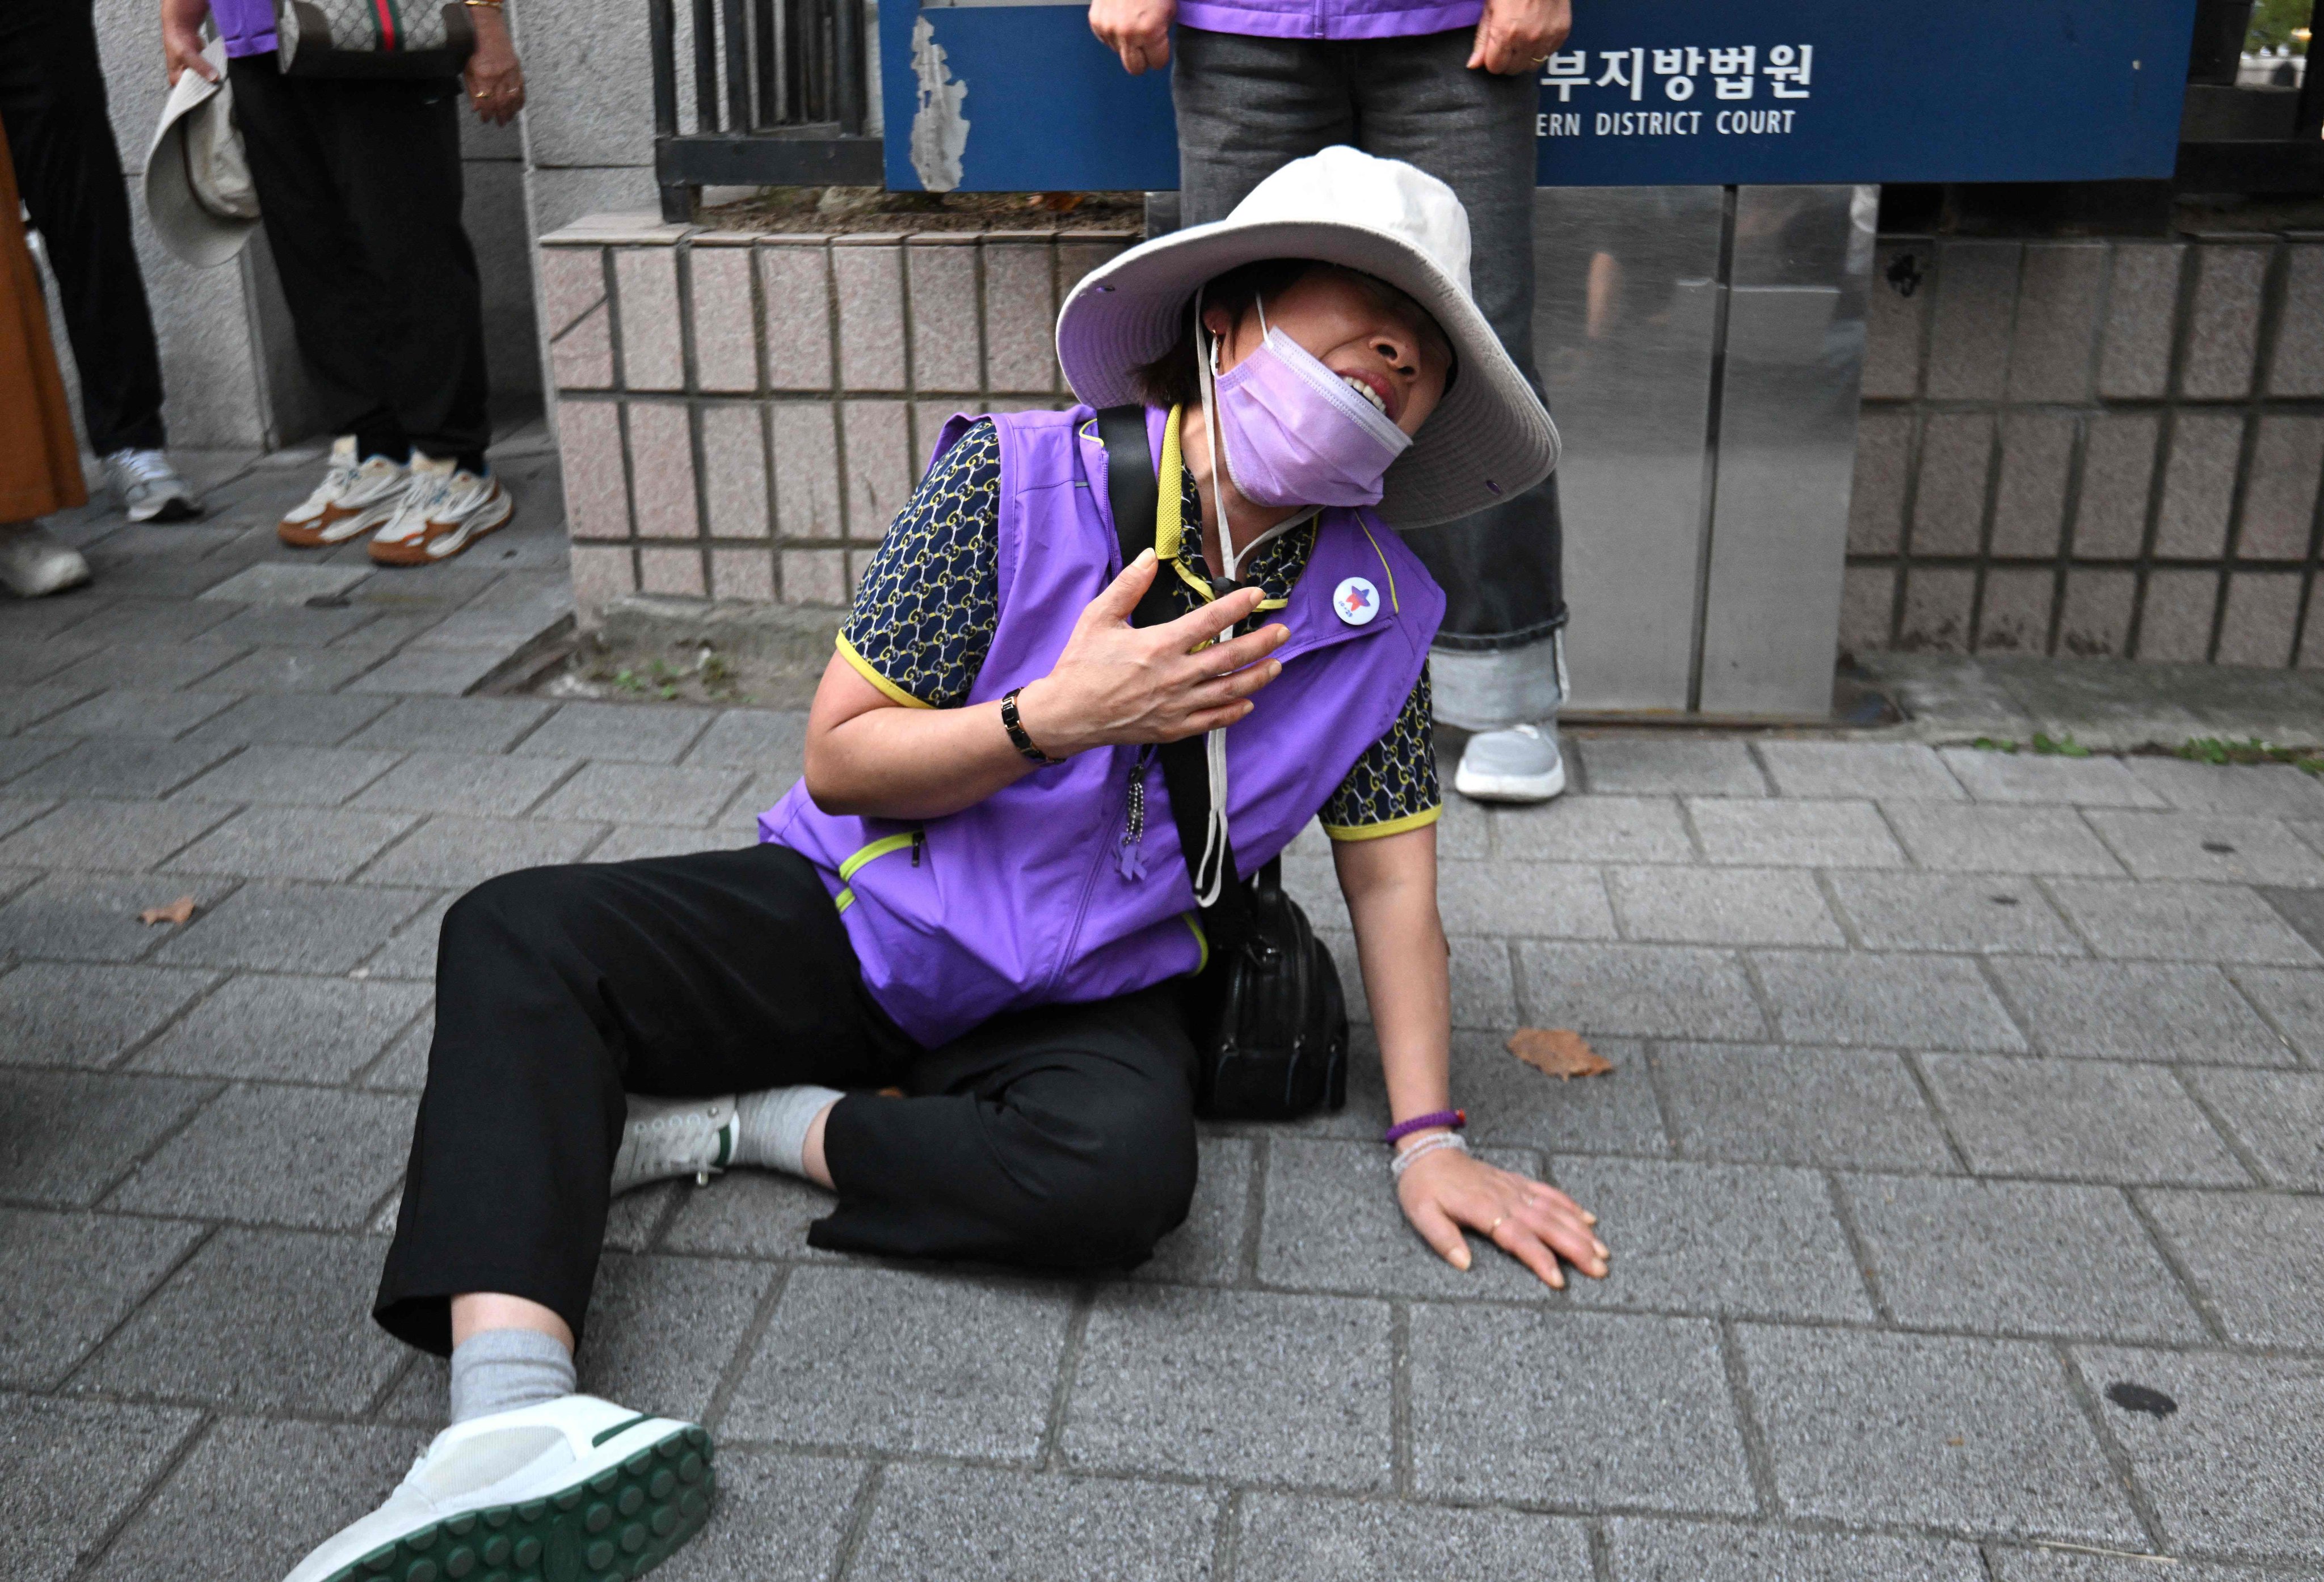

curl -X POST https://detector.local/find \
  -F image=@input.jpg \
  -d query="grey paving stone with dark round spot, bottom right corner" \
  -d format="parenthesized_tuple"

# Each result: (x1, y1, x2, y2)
(2075, 1347, 2324, 1561)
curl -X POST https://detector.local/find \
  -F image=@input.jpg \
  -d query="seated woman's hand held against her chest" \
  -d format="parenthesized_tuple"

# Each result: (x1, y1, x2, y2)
(1018, 551, 1290, 757)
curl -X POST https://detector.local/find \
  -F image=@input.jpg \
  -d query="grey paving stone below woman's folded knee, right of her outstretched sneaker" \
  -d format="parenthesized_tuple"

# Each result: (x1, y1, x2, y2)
(725, 1266, 1071, 1461)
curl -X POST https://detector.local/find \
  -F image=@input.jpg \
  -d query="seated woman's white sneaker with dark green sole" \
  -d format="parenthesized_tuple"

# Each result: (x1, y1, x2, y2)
(286, 1396, 718, 1582)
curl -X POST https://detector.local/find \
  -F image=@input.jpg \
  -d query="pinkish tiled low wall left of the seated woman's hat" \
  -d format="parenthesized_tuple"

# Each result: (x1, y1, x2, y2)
(541, 216, 1134, 618)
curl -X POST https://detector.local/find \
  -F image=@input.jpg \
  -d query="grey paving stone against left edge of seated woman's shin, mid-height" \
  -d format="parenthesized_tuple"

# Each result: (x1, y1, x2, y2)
(104, 1085, 418, 1231)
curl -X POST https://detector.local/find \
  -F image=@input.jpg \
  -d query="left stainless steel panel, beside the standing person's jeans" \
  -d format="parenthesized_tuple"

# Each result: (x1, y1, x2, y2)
(1534, 186, 1738, 711)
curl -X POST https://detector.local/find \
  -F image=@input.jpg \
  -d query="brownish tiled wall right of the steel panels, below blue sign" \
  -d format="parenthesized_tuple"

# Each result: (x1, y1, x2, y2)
(1841, 235, 2324, 669)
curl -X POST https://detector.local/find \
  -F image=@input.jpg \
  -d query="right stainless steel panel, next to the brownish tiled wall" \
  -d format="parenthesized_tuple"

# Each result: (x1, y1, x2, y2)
(1691, 186, 1878, 718)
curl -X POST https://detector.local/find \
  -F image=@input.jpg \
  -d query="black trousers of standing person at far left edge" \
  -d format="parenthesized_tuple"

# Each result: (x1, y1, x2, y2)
(0, 0, 165, 455)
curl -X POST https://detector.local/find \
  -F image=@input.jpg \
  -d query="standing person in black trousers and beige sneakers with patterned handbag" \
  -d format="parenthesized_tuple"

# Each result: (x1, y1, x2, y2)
(161, 0, 525, 564)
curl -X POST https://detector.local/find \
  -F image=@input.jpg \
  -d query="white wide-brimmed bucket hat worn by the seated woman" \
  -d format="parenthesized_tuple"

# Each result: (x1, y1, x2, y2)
(1058, 146, 1557, 528)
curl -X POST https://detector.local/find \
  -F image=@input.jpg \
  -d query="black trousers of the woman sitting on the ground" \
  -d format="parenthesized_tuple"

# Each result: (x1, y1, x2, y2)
(372, 846, 1194, 1352)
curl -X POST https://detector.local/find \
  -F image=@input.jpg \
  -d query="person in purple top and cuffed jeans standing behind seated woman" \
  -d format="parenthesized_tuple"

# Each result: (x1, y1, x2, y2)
(1090, 0, 1573, 801)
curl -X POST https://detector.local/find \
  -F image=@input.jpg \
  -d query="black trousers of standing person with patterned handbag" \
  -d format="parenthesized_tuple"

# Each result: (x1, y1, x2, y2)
(228, 53, 492, 467)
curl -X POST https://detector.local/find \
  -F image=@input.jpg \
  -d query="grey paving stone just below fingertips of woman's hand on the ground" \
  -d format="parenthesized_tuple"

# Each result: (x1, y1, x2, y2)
(1411, 1303, 1752, 1514)
